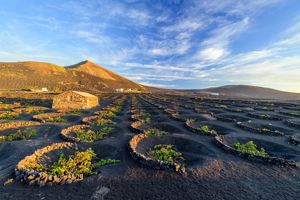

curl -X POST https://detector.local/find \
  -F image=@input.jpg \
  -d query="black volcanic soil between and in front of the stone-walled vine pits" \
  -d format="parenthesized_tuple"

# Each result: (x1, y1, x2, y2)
(0, 95, 300, 200)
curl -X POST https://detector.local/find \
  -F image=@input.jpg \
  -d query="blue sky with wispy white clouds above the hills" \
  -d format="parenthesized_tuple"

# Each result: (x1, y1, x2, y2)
(0, 0, 300, 92)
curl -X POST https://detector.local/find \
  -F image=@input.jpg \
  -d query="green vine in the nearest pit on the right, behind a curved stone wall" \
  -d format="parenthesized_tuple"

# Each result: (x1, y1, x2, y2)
(234, 140, 268, 157)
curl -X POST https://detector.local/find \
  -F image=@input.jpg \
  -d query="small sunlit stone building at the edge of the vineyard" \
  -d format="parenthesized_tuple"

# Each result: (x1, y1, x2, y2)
(52, 91, 99, 110)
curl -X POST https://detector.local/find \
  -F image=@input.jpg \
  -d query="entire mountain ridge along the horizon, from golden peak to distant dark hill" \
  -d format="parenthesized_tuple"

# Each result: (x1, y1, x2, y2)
(0, 60, 300, 100)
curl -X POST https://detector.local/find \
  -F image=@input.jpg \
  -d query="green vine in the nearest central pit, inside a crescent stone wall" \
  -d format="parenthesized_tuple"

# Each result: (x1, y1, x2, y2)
(148, 144, 184, 163)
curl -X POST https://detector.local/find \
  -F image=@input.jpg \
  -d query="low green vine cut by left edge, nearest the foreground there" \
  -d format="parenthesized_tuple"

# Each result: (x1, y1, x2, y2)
(0, 128, 38, 142)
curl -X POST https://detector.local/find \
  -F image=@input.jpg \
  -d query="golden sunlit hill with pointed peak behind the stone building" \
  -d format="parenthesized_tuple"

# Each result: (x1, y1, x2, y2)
(0, 61, 145, 92)
